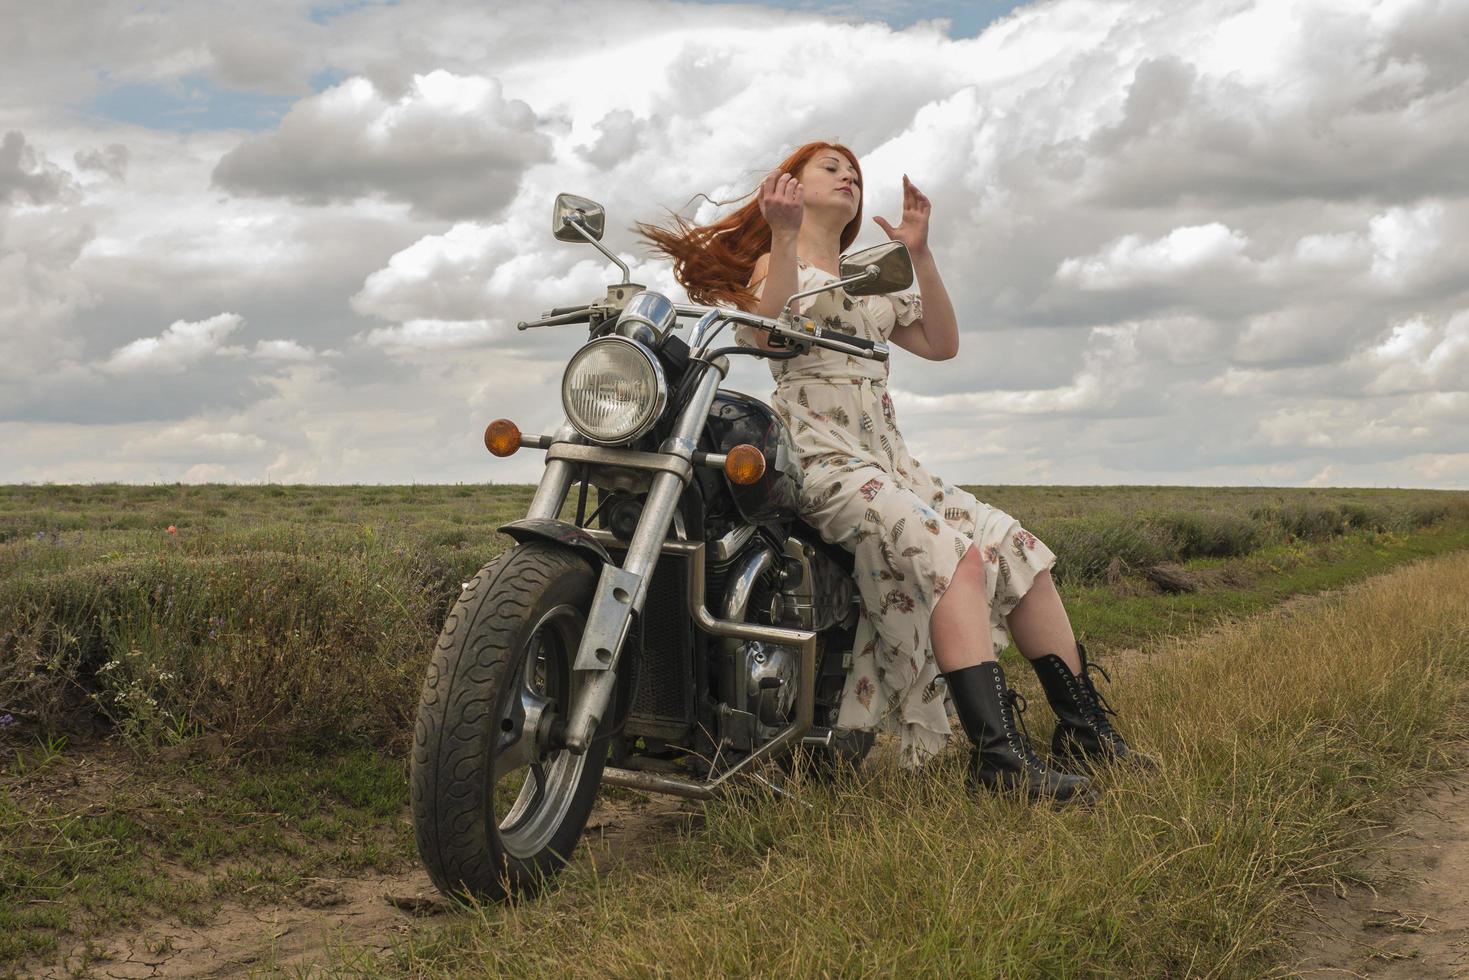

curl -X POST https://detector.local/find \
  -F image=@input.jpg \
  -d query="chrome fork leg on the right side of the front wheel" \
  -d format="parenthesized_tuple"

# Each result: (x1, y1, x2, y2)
(558, 363, 726, 754)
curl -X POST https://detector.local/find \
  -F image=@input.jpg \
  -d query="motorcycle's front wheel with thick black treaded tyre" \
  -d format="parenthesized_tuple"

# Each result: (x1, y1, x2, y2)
(411, 542, 607, 901)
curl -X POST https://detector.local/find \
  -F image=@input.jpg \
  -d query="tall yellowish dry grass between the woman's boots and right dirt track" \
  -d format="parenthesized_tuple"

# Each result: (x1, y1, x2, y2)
(373, 554, 1469, 977)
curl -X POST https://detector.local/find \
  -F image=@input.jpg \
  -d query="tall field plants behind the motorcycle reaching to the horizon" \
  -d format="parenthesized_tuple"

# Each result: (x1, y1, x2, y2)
(0, 486, 1469, 745)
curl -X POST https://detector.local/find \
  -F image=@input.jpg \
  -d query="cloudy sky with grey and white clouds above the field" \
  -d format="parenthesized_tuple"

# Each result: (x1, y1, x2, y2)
(0, 0, 1469, 488)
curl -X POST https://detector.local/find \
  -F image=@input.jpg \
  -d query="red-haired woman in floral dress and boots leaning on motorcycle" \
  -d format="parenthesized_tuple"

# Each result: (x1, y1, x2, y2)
(642, 143, 1152, 799)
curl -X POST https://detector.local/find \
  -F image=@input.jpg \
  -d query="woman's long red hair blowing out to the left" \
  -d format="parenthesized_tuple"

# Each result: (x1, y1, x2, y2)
(638, 141, 867, 310)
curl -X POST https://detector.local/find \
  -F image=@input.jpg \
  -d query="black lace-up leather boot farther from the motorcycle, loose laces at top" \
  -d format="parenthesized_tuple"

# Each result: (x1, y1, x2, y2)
(1030, 644, 1158, 773)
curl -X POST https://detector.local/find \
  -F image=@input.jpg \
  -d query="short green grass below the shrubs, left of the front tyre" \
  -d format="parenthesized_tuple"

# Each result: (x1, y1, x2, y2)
(0, 745, 413, 968)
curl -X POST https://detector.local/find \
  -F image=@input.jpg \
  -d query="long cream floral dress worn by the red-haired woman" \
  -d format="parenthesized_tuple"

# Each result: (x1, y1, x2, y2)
(736, 259, 1056, 767)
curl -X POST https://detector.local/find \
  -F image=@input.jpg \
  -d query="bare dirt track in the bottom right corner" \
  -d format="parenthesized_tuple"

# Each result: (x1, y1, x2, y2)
(1297, 749, 1469, 980)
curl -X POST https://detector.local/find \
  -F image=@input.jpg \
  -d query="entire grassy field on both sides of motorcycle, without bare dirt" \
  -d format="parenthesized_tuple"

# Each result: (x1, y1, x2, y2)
(0, 486, 1469, 976)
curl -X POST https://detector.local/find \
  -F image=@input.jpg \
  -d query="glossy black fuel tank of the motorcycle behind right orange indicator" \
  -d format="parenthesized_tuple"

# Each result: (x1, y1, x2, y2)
(707, 389, 801, 525)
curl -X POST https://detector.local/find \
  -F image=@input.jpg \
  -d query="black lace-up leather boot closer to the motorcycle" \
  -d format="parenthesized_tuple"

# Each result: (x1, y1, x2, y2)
(945, 661, 1094, 802)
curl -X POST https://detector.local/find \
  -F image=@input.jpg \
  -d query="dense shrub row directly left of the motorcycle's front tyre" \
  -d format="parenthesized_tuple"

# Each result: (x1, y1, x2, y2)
(0, 548, 452, 743)
